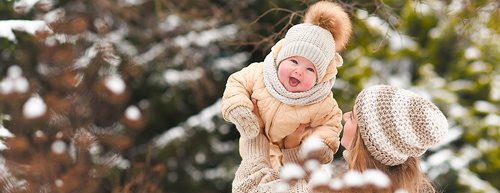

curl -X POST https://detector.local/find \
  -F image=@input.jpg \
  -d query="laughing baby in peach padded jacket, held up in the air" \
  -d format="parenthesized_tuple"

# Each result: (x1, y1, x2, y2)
(222, 1, 352, 168)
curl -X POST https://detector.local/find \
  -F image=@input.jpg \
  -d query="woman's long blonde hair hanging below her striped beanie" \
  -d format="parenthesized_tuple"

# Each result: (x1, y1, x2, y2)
(346, 129, 436, 193)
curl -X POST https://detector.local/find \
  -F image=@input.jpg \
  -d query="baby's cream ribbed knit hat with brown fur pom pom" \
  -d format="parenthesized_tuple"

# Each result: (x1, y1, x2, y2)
(276, 1, 352, 82)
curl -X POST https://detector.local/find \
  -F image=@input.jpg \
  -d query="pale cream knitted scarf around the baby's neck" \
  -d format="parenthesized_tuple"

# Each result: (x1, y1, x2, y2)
(263, 52, 335, 105)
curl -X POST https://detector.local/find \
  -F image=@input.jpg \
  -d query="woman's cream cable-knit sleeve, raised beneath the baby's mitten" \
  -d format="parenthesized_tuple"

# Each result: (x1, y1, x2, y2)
(232, 134, 311, 193)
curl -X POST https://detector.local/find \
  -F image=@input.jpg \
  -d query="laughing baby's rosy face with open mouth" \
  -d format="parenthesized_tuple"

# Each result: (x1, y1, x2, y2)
(278, 56, 317, 92)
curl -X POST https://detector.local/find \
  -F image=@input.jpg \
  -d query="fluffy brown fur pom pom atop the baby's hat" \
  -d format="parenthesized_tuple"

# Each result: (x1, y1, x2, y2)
(304, 1, 352, 52)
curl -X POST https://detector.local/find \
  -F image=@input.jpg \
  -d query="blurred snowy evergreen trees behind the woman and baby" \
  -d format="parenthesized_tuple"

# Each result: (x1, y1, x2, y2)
(0, 0, 500, 193)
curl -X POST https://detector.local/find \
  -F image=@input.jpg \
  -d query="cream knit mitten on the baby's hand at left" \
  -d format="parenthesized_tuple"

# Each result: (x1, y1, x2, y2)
(229, 106, 259, 139)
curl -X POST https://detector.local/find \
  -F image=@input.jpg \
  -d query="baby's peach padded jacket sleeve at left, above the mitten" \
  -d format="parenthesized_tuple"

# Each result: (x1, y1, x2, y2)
(222, 63, 259, 121)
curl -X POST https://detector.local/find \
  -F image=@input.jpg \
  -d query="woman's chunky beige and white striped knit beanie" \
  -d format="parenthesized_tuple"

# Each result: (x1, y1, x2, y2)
(355, 85, 448, 166)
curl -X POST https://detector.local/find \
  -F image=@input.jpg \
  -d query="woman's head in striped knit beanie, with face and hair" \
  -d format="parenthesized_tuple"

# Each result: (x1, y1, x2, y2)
(341, 85, 448, 192)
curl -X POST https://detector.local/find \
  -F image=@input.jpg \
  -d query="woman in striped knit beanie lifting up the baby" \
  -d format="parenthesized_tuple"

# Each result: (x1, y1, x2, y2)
(233, 85, 448, 193)
